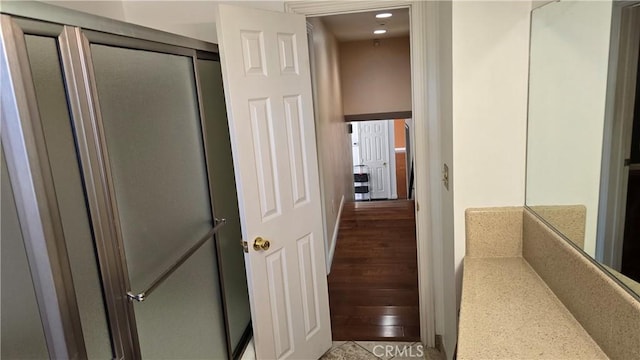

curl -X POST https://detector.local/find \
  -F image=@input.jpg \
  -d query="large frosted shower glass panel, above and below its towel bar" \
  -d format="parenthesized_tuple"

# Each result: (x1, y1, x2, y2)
(91, 44, 226, 359)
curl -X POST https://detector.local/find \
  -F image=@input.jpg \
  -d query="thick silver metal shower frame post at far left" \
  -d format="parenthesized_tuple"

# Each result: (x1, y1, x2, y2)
(0, 15, 87, 359)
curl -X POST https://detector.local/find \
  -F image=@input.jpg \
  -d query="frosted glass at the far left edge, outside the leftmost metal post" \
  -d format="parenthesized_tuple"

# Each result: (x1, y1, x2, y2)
(0, 148, 49, 359)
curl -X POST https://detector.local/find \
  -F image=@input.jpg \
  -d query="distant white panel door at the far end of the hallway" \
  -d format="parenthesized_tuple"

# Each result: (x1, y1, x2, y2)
(360, 120, 391, 199)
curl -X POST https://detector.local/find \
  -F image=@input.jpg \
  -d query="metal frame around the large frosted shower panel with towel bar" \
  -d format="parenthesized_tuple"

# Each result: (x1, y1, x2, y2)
(60, 26, 231, 358)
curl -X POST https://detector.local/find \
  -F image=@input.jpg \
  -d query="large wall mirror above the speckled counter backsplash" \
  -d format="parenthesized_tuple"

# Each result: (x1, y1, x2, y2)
(526, 1, 640, 294)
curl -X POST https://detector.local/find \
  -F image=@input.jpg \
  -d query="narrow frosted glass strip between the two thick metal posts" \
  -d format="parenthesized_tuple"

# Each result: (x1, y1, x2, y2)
(25, 35, 113, 359)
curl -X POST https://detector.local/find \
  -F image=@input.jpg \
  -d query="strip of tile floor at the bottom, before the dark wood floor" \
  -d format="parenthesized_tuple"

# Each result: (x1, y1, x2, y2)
(242, 340, 445, 360)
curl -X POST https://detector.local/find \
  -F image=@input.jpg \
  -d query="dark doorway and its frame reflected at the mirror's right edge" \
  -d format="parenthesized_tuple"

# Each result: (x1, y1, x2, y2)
(596, 5, 640, 294)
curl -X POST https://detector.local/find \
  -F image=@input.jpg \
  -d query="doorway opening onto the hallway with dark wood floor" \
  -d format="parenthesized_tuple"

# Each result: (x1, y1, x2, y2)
(308, 8, 428, 355)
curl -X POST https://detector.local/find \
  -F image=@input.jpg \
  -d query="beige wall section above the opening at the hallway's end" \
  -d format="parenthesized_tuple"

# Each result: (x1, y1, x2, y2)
(340, 36, 411, 115)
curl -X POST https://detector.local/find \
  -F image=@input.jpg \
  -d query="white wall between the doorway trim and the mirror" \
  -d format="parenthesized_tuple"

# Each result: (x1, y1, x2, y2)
(445, 1, 531, 301)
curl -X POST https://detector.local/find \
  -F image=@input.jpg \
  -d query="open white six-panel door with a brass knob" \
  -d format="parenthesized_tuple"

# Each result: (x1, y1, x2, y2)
(217, 5, 331, 359)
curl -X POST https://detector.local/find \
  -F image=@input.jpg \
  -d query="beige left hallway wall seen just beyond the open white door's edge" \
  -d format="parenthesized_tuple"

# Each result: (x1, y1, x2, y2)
(309, 18, 353, 270)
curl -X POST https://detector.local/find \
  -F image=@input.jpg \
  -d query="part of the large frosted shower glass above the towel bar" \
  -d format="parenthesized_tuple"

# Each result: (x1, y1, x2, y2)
(91, 45, 212, 291)
